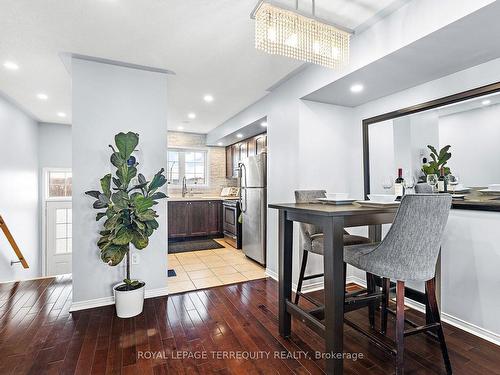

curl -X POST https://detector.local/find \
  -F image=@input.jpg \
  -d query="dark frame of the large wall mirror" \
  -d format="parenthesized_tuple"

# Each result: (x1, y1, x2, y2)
(362, 82, 500, 211)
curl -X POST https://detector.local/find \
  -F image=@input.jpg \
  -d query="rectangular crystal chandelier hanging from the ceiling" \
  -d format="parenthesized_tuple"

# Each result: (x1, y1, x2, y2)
(252, 0, 352, 69)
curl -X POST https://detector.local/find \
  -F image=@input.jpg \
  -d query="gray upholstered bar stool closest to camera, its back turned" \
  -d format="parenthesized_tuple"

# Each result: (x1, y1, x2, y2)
(344, 194, 452, 375)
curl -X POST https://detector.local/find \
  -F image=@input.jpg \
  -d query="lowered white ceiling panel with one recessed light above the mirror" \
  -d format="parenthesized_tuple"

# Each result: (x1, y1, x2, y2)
(303, 1, 500, 107)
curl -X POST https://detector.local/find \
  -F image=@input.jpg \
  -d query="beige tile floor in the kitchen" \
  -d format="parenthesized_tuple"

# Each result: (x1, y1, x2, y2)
(168, 240, 266, 294)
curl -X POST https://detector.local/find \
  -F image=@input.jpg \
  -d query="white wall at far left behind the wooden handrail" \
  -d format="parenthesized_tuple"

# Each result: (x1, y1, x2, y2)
(0, 97, 40, 281)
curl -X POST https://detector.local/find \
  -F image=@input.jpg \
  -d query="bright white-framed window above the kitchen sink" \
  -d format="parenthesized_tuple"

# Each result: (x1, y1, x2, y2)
(167, 149, 208, 185)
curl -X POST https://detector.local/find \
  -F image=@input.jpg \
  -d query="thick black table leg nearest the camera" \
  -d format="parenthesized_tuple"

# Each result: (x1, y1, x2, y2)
(323, 217, 344, 375)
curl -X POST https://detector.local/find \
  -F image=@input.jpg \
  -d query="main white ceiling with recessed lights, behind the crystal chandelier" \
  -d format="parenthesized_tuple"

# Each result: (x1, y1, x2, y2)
(0, 0, 401, 133)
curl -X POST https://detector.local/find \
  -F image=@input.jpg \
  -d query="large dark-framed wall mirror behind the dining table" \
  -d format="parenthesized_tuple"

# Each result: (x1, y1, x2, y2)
(363, 83, 500, 211)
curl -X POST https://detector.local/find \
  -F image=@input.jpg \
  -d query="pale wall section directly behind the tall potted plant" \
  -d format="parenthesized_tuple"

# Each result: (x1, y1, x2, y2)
(72, 59, 167, 303)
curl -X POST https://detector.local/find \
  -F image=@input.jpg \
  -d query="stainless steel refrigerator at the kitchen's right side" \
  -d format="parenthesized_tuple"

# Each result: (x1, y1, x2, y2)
(239, 153, 267, 265)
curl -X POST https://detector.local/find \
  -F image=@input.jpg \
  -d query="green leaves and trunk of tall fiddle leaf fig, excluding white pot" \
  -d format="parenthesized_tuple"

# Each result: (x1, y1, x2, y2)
(85, 132, 167, 288)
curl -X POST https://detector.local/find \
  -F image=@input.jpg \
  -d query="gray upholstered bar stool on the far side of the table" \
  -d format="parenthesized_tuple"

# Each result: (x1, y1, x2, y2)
(295, 190, 371, 304)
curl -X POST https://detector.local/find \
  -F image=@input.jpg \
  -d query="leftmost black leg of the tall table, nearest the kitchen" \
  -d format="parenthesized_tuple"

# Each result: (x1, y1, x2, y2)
(278, 210, 293, 337)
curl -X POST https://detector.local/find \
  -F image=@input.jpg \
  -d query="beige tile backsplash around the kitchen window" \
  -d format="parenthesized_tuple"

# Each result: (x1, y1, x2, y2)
(168, 131, 237, 195)
